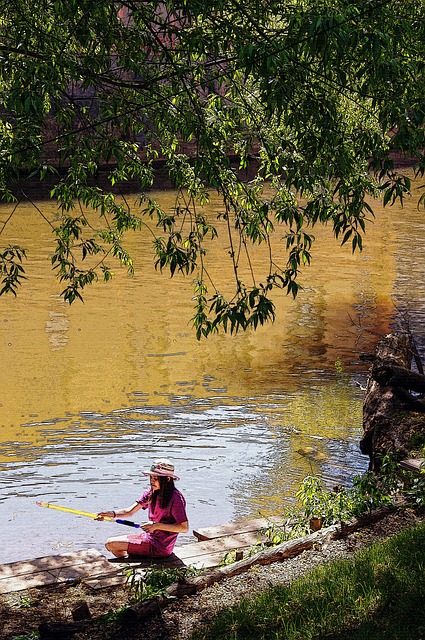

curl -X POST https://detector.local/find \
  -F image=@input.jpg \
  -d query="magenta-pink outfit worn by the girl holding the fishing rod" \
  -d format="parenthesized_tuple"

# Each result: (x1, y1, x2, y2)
(128, 489, 188, 557)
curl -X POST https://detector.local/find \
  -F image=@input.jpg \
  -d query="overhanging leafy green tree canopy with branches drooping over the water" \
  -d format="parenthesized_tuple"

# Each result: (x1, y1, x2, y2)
(0, 0, 425, 338)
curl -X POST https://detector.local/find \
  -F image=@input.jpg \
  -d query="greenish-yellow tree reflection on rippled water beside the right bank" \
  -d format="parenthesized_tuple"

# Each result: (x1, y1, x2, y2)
(231, 374, 367, 518)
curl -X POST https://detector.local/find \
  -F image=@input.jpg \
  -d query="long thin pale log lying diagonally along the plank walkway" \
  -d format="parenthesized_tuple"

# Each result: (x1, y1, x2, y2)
(122, 508, 390, 624)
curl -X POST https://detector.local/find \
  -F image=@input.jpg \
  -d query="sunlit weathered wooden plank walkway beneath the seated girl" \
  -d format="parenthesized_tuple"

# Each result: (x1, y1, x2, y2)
(0, 518, 280, 594)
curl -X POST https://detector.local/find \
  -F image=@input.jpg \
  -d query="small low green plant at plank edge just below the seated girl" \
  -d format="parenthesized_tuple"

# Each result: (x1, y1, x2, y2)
(124, 565, 198, 602)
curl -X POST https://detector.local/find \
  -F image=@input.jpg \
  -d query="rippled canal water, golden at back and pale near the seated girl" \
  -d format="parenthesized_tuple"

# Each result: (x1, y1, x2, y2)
(0, 169, 425, 563)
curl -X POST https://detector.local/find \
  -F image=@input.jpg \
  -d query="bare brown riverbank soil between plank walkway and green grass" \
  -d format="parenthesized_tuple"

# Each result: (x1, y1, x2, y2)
(0, 508, 425, 640)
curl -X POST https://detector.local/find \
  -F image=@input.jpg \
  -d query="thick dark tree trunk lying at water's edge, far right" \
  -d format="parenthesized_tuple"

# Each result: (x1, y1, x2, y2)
(360, 331, 425, 471)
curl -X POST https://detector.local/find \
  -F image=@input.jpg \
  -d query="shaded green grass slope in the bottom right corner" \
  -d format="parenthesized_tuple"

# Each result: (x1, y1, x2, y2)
(194, 524, 425, 640)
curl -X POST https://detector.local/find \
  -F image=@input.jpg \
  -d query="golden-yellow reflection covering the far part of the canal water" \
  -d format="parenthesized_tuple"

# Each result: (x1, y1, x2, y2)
(0, 175, 414, 456)
